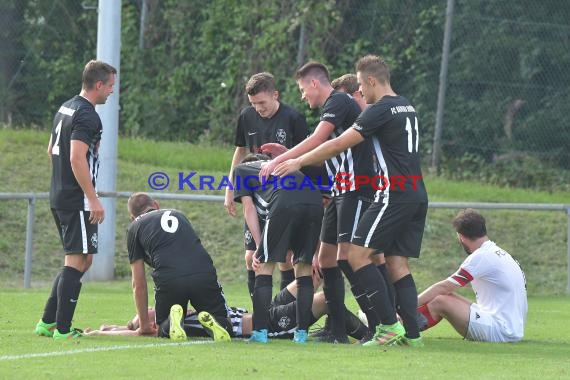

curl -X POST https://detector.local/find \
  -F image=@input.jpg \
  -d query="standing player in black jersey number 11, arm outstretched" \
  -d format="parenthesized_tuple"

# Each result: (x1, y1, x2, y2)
(275, 55, 428, 346)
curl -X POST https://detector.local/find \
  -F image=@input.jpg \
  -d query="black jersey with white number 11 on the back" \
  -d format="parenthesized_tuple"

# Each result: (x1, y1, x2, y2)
(354, 96, 427, 203)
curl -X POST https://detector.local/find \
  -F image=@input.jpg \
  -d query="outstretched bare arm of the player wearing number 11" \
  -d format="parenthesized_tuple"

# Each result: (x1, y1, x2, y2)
(273, 128, 364, 176)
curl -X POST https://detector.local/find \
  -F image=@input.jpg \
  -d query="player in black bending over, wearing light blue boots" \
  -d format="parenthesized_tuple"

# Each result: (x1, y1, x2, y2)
(234, 156, 323, 343)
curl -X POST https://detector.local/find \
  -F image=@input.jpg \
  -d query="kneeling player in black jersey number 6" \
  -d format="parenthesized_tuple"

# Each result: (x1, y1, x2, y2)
(127, 193, 232, 341)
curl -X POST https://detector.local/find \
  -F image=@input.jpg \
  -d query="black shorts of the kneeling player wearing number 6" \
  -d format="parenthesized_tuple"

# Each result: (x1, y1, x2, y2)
(154, 273, 229, 325)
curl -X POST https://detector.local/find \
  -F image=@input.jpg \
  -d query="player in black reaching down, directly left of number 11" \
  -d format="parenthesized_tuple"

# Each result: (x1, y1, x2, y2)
(261, 62, 375, 343)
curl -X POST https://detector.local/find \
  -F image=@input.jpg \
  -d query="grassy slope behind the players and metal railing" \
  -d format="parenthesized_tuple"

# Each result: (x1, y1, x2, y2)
(0, 129, 570, 295)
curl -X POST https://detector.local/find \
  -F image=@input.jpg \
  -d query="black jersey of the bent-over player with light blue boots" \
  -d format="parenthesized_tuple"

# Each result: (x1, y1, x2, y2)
(233, 161, 323, 219)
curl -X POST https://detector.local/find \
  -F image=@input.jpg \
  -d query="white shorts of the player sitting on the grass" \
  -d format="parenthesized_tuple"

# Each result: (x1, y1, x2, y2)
(465, 303, 518, 343)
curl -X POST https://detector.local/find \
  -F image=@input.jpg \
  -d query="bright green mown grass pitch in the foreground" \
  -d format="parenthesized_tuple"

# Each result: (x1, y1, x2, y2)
(0, 281, 570, 379)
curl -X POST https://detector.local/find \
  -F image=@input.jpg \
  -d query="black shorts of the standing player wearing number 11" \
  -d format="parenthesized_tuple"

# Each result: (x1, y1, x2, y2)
(352, 202, 427, 258)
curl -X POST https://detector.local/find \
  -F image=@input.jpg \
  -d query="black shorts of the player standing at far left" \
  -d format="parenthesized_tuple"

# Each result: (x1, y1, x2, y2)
(51, 208, 99, 255)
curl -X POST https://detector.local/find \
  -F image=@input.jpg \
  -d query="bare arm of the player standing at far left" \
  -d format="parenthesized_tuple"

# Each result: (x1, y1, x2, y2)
(69, 140, 105, 224)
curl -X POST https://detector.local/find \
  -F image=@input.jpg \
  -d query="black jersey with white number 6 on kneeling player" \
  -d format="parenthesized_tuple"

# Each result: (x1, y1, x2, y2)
(127, 209, 216, 285)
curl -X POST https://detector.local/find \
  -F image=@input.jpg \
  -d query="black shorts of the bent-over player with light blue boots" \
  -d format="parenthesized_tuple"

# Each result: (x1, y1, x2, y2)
(255, 204, 323, 264)
